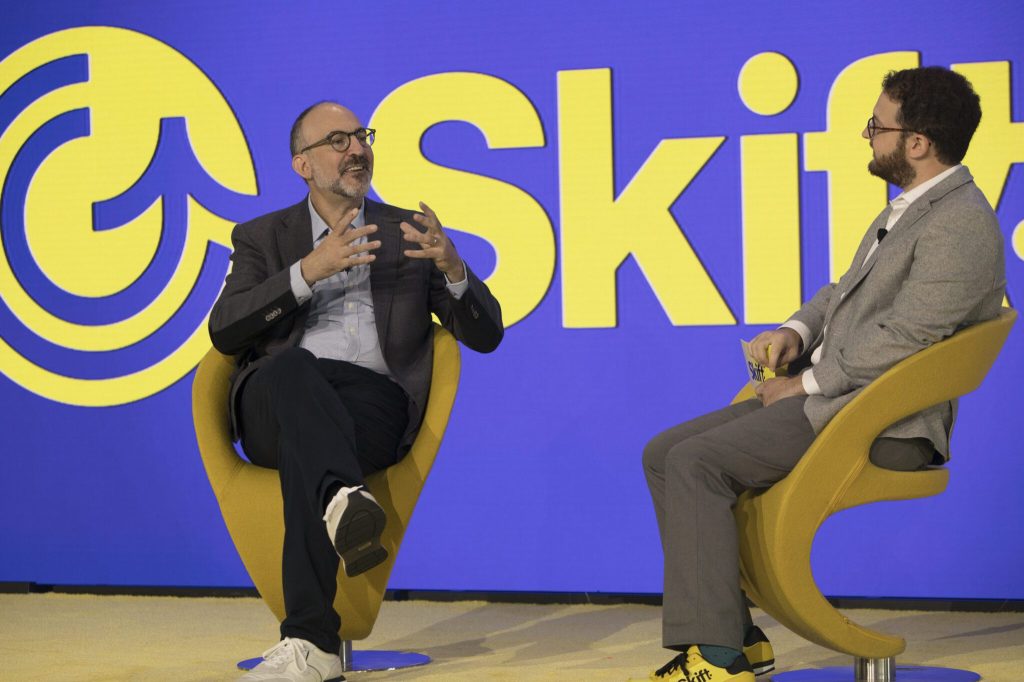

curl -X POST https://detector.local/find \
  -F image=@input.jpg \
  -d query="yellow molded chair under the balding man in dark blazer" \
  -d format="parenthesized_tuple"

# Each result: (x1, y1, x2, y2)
(193, 325, 461, 671)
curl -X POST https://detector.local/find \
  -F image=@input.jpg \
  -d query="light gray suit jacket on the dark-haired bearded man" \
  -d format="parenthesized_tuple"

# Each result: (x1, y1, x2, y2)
(792, 167, 1006, 459)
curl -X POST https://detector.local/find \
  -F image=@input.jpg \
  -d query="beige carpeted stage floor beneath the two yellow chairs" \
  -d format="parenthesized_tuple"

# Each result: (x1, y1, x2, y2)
(0, 594, 1024, 682)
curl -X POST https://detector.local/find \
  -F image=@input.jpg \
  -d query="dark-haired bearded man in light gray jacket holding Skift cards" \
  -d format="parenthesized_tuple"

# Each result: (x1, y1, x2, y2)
(644, 68, 1006, 682)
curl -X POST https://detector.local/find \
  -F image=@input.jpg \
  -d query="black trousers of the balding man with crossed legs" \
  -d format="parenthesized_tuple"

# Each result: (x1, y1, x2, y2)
(239, 348, 409, 652)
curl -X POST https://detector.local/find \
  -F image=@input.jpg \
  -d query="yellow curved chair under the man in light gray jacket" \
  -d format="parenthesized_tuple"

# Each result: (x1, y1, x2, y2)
(735, 308, 1017, 681)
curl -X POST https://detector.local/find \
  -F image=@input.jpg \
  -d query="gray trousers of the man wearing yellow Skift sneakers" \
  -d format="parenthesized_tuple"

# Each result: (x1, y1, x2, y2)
(643, 395, 933, 651)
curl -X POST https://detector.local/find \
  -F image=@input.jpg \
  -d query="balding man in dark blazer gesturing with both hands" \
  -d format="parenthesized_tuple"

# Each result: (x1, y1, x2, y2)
(210, 102, 504, 681)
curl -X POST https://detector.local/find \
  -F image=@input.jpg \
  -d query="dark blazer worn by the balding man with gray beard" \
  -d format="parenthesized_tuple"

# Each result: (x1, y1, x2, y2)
(210, 199, 504, 454)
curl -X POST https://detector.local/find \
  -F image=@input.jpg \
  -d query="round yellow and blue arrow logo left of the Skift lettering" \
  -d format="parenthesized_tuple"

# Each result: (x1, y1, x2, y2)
(0, 27, 256, 407)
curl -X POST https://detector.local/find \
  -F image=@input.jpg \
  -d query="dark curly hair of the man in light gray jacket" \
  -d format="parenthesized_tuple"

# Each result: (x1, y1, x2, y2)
(882, 67, 981, 166)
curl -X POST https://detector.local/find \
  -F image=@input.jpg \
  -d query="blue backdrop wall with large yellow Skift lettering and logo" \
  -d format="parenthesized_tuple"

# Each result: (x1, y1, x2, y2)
(0, 0, 1024, 598)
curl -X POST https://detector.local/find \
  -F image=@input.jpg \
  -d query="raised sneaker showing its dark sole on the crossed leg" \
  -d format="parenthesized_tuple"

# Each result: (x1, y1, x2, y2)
(324, 486, 387, 578)
